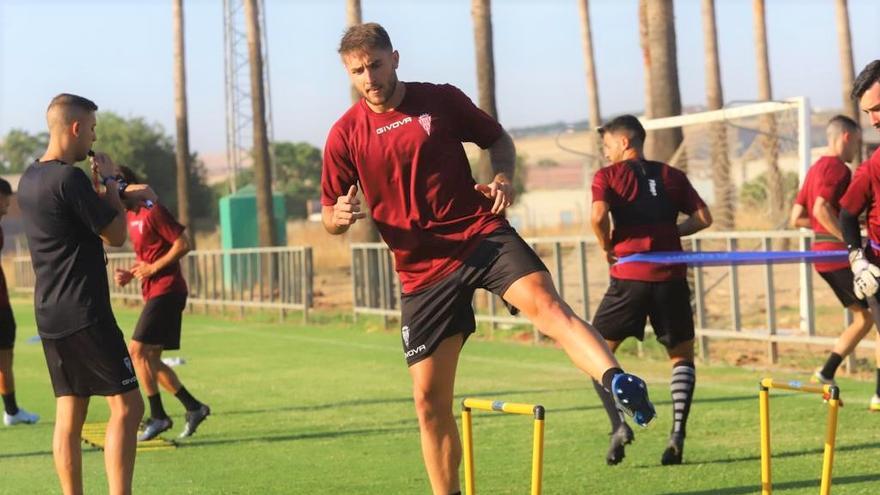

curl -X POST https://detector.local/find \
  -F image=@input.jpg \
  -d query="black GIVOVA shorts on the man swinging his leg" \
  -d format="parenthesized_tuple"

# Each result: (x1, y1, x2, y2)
(400, 227, 547, 366)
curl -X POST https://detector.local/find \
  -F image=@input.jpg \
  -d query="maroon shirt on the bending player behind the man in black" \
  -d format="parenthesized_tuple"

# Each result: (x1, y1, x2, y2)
(125, 203, 187, 301)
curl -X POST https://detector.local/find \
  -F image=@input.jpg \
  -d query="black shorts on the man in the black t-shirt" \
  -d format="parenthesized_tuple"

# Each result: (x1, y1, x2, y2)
(42, 323, 138, 397)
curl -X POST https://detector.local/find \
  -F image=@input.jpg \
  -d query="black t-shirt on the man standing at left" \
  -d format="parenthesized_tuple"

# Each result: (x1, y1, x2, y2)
(18, 161, 117, 339)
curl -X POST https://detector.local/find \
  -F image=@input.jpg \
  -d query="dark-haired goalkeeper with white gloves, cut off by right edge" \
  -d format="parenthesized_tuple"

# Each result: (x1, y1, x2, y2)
(840, 60, 880, 411)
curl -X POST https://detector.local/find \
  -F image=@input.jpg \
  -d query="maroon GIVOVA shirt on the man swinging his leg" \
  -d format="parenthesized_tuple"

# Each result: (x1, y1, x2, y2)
(321, 83, 507, 293)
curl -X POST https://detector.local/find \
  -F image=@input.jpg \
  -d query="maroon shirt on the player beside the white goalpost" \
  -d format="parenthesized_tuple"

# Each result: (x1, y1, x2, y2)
(794, 156, 852, 272)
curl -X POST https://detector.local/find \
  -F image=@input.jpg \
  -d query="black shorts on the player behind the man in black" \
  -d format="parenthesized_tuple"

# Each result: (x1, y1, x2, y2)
(131, 292, 186, 350)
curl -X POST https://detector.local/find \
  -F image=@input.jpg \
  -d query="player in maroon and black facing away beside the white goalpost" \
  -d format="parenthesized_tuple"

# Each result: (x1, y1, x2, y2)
(789, 115, 880, 402)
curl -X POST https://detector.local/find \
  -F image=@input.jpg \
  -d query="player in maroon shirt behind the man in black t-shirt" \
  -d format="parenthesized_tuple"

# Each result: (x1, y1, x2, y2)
(114, 167, 211, 441)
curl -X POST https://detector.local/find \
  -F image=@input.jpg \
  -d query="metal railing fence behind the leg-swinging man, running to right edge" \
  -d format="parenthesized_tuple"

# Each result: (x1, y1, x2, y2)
(351, 231, 875, 366)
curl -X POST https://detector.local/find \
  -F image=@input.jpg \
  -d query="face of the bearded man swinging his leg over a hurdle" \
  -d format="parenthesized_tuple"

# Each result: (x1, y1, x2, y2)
(342, 49, 399, 106)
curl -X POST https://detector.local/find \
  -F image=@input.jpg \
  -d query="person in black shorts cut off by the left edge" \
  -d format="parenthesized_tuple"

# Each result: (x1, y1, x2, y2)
(0, 179, 40, 426)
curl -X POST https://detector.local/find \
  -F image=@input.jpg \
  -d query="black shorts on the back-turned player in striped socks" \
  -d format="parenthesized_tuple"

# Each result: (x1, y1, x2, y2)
(593, 277, 694, 349)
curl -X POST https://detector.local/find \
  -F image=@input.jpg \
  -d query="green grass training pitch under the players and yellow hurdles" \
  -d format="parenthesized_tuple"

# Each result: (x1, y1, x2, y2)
(0, 303, 880, 495)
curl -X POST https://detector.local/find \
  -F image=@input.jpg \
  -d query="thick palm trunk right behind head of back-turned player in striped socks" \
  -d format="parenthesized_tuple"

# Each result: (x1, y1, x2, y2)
(645, 0, 687, 170)
